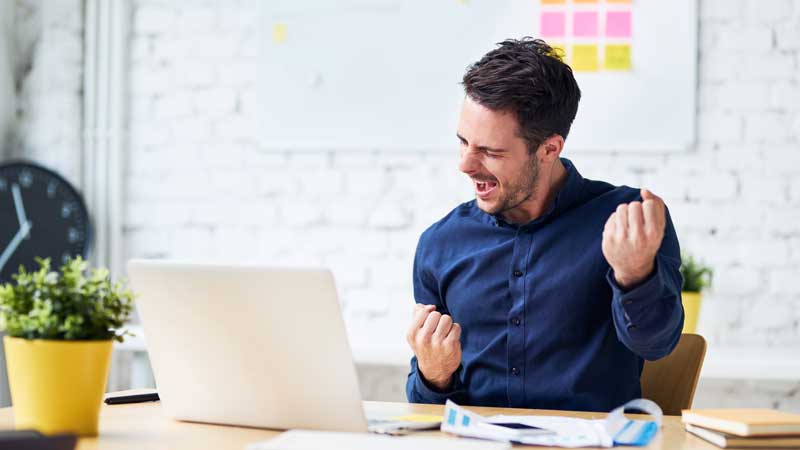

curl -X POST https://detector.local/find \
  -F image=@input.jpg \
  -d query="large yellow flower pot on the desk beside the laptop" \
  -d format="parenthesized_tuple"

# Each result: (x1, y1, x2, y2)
(3, 336, 112, 436)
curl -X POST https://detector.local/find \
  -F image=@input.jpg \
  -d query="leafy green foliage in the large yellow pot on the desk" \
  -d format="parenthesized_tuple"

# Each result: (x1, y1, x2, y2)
(0, 256, 133, 342)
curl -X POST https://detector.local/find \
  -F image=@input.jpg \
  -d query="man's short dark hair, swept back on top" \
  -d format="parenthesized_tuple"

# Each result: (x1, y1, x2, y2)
(462, 37, 581, 152)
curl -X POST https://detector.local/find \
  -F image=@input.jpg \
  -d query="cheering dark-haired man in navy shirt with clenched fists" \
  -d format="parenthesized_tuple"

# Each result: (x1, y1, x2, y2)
(406, 38, 683, 411)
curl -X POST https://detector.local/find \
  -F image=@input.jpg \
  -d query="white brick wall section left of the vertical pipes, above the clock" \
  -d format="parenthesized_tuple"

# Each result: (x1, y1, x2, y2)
(11, 0, 83, 184)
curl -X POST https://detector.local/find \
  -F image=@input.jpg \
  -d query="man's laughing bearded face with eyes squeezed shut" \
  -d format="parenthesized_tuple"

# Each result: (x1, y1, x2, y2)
(458, 96, 539, 221)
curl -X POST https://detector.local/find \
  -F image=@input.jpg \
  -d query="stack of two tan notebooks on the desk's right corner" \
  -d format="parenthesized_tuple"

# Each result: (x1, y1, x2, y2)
(682, 409, 800, 449)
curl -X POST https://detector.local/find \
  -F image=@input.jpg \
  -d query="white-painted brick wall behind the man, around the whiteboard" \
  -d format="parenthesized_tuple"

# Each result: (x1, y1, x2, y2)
(10, 0, 800, 404)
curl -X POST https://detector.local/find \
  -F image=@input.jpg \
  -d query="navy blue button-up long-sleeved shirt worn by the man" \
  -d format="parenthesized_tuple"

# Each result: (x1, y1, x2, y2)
(406, 159, 683, 411)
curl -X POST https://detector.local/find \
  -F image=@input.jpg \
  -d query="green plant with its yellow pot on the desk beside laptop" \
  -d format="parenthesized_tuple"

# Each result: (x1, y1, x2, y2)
(0, 257, 133, 436)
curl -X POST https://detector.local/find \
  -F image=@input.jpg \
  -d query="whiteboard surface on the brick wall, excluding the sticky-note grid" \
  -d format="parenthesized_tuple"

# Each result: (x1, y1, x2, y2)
(258, 0, 697, 152)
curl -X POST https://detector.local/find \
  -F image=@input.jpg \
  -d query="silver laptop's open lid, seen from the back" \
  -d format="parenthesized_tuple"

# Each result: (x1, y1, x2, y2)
(128, 260, 367, 431)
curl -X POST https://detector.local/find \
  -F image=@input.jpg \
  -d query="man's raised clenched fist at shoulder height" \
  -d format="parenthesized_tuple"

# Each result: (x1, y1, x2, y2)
(603, 189, 667, 288)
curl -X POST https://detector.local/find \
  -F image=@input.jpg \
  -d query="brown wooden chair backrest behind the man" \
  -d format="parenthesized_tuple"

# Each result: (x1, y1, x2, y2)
(640, 334, 706, 415)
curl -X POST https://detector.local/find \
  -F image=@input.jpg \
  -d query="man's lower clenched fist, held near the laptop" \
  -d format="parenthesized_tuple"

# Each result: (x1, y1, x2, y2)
(406, 304, 461, 390)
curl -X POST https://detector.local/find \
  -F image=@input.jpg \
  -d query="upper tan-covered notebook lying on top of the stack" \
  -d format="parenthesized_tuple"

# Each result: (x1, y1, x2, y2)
(682, 408, 800, 436)
